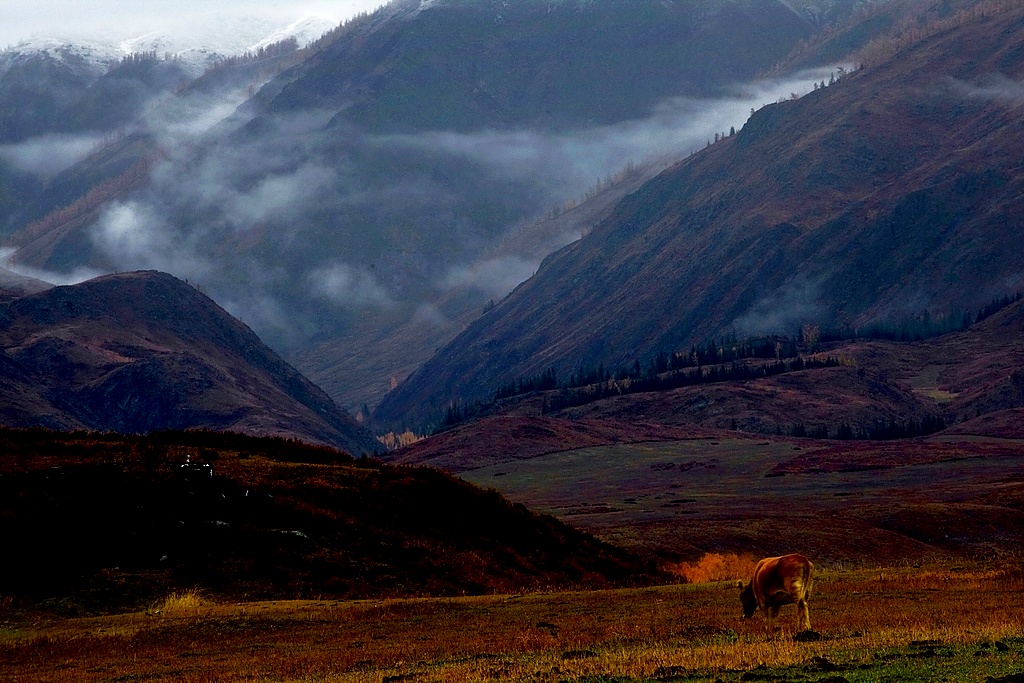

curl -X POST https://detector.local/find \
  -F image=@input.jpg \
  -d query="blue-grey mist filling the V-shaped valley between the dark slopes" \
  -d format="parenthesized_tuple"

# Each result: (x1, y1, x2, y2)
(0, 0, 847, 408)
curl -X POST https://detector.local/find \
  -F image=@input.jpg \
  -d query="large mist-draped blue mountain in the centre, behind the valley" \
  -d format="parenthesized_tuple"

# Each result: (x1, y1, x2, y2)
(11, 0, 862, 419)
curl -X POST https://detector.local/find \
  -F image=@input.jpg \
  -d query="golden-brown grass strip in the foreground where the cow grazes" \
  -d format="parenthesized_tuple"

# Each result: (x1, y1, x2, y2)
(0, 564, 1024, 683)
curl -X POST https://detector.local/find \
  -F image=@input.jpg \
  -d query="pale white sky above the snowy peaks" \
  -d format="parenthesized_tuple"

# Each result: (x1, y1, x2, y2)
(0, 0, 386, 48)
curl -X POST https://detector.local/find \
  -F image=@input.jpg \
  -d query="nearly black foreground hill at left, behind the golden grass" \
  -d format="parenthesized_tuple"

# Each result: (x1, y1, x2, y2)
(0, 430, 654, 611)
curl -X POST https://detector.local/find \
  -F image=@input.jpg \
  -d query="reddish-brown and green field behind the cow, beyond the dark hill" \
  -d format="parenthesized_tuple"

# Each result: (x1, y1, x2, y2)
(460, 434, 1024, 566)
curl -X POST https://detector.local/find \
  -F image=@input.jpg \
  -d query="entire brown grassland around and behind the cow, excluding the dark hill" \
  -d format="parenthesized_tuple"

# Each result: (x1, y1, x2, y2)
(0, 436, 1024, 683)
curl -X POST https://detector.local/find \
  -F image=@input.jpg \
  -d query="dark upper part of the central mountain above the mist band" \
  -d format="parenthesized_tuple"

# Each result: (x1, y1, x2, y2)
(256, 0, 839, 131)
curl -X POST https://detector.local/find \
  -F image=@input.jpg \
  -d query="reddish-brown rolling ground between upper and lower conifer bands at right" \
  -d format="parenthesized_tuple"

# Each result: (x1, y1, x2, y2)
(552, 294, 1024, 438)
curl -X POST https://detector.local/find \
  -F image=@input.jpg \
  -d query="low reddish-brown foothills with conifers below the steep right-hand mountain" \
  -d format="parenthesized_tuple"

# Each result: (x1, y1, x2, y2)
(386, 296, 1024, 481)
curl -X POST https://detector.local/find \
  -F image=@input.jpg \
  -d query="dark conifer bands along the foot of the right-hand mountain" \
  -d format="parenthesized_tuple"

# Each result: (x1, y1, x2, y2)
(428, 293, 1024, 439)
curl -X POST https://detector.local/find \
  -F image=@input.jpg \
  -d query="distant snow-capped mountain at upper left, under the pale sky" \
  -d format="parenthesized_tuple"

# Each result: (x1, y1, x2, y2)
(0, 31, 327, 240)
